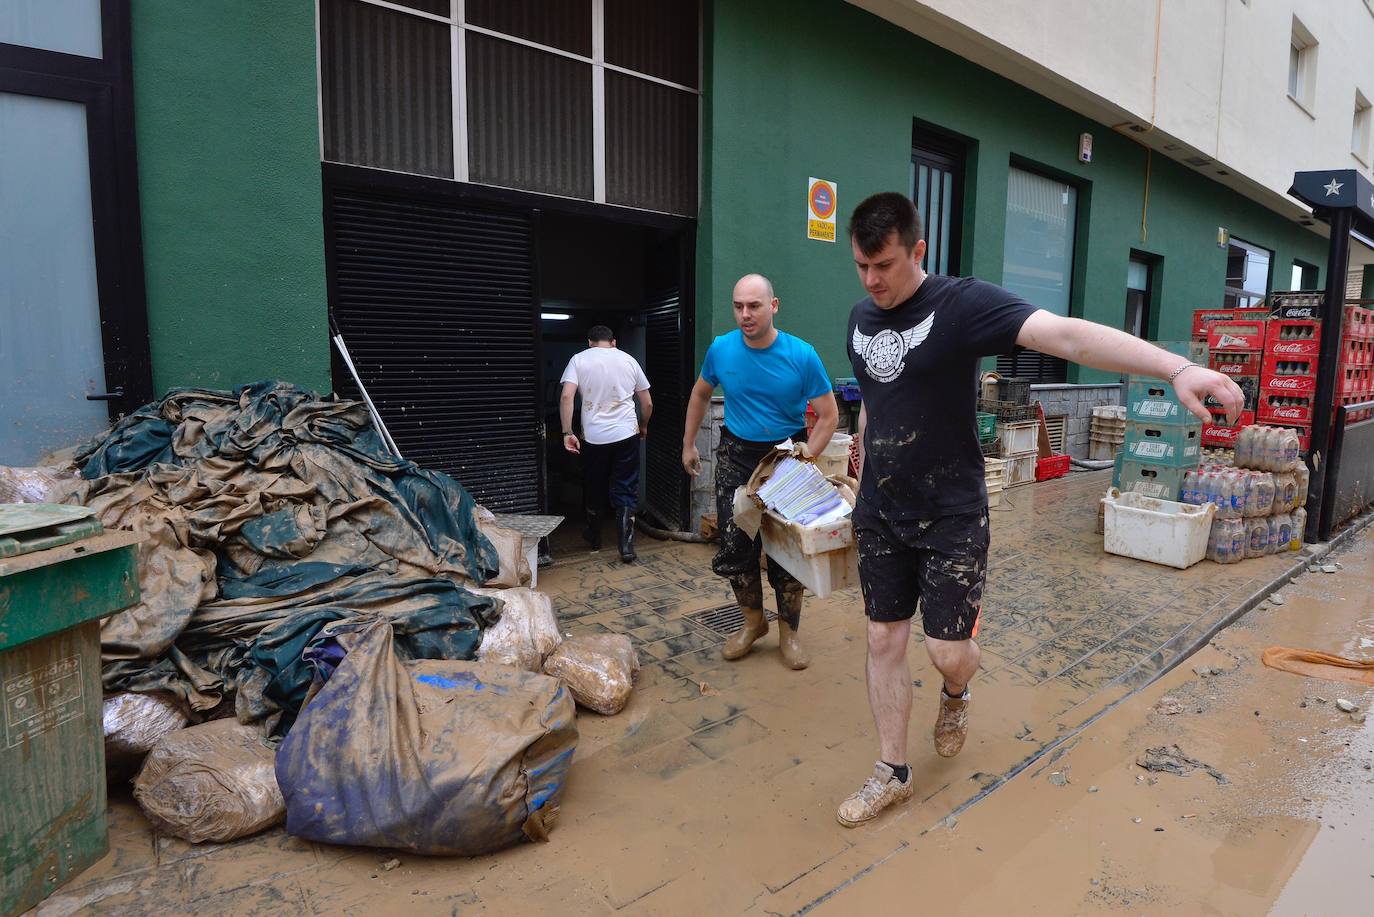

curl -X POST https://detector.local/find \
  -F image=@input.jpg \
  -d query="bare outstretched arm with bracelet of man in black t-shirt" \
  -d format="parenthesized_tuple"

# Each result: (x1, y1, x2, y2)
(1017, 309, 1245, 423)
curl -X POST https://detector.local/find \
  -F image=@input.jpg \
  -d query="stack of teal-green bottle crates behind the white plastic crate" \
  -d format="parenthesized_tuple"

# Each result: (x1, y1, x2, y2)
(1112, 377, 1202, 500)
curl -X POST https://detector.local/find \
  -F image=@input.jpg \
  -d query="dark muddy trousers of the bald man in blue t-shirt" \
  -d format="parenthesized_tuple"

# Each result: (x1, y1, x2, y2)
(710, 428, 807, 630)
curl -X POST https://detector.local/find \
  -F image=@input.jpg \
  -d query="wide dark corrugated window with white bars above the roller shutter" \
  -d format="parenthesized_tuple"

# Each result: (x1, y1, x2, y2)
(317, 0, 701, 216)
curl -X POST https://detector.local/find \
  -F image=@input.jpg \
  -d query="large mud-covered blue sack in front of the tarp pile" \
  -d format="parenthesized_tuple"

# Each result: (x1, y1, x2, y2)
(276, 617, 577, 857)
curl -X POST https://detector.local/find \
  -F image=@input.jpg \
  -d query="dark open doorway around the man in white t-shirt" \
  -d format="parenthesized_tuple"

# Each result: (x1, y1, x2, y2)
(536, 213, 691, 555)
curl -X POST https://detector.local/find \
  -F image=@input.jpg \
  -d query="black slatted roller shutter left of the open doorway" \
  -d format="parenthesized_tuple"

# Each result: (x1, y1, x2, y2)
(326, 186, 541, 513)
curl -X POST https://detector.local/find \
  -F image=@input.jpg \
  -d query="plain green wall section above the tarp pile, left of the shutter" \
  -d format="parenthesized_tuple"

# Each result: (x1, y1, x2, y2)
(132, 0, 330, 395)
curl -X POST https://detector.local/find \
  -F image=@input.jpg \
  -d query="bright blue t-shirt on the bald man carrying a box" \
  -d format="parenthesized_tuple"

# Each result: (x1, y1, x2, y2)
(701, 329, 833, 443)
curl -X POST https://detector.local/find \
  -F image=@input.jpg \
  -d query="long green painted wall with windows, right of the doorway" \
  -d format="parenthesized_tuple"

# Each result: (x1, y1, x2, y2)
(697, 0, 1326, 382)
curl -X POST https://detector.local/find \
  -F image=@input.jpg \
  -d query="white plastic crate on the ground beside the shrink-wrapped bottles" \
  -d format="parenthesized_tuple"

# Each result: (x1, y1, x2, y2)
(1102, 492, 1216, 571)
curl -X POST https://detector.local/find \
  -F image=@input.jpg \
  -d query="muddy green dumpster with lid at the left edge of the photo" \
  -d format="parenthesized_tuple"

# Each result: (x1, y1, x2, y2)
(0, 503, 140, 917)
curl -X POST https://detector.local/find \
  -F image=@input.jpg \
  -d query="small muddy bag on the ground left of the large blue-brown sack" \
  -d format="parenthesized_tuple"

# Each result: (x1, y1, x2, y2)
(133, 719, 286, 844)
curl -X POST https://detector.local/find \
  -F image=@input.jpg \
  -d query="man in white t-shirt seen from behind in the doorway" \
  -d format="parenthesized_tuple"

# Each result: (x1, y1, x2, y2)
(558, 324, 654, 564)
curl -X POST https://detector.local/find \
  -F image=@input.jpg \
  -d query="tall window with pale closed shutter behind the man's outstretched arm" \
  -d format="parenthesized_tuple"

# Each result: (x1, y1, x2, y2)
(998, 168, 1079, 382)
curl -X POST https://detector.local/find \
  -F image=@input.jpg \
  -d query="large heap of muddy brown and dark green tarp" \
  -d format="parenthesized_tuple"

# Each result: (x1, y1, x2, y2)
(60, 382, 500, 734)
